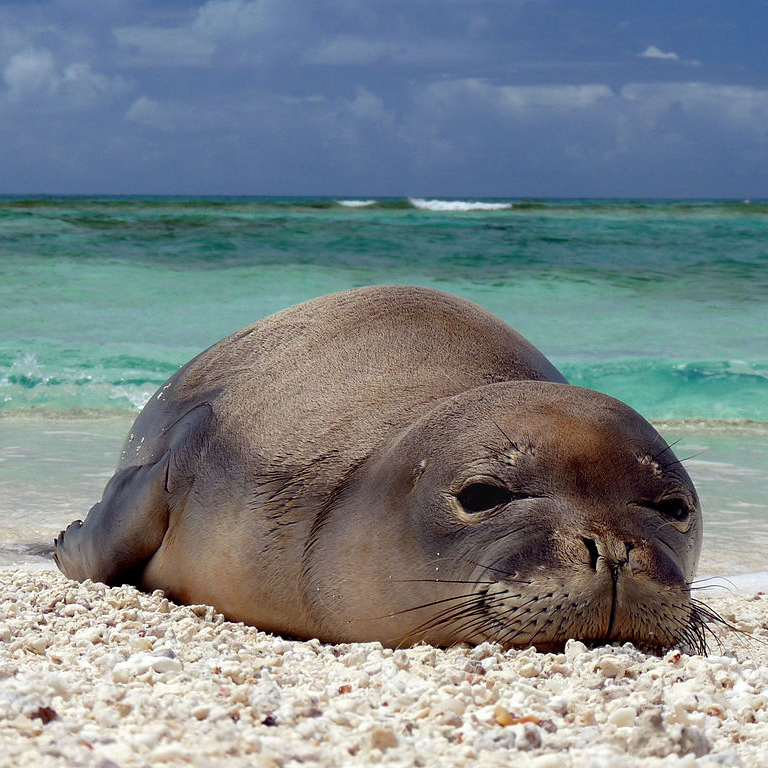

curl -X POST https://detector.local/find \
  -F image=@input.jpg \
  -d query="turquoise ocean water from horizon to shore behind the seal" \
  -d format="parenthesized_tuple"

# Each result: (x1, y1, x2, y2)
(0, 196, 768, 575)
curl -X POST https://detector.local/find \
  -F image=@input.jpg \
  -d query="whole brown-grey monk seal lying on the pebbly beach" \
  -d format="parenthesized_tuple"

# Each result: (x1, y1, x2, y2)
(54, 286, 706, 650)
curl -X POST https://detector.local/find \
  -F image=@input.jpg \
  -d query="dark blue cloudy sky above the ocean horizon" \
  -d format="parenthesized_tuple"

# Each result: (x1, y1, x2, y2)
(0, 0, 768, 198)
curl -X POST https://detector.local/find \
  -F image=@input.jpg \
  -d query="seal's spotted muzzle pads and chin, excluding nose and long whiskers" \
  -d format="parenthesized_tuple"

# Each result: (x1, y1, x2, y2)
(478, 563, 696, 652)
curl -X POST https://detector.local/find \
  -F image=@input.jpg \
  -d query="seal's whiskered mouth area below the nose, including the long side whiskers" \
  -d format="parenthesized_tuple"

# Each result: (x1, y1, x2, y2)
(364, 564, 716, 654)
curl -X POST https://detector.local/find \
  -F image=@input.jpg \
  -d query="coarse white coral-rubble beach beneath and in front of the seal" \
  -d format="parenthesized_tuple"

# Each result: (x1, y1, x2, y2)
(0, 570, 768, 768)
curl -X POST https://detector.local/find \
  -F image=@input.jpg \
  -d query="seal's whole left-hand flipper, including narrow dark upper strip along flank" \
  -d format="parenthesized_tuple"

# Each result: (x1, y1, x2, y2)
(53, 403, 211, 585)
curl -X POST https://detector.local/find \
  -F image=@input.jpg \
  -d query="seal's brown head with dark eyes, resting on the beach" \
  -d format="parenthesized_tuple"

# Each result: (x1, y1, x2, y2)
(303, 382, 703, 650)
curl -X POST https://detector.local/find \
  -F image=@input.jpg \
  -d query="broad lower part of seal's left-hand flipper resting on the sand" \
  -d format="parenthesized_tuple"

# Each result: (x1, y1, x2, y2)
(53, 451, 171, 585)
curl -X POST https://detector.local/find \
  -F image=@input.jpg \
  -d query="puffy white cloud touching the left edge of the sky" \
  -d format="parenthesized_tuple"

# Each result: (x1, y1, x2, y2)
(3, 48, 128, 106)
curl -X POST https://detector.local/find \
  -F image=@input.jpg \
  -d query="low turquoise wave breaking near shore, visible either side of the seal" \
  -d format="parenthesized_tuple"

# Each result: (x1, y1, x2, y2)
(0, 350, 768, 422)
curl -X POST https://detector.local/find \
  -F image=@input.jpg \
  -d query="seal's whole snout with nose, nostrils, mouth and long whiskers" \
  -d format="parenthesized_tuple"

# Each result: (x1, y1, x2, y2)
(368, 532, 713, 653)
